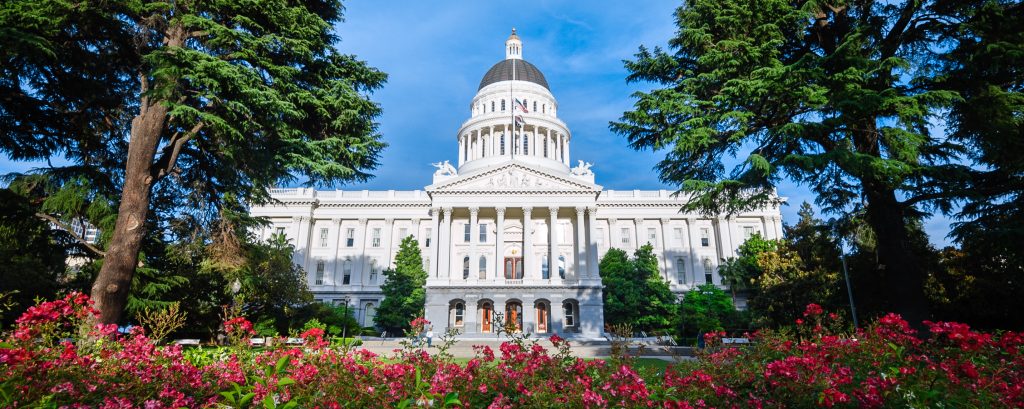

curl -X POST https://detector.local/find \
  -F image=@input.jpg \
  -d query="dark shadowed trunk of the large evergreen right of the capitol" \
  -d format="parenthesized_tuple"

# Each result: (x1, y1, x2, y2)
(864, 182, 929, 329)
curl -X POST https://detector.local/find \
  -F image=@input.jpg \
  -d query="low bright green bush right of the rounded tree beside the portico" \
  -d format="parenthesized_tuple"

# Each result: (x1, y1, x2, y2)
(678, 284, 736, 336)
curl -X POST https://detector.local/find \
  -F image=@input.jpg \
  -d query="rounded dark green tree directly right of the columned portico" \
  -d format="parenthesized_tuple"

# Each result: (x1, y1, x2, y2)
(598, 244, 678, 331)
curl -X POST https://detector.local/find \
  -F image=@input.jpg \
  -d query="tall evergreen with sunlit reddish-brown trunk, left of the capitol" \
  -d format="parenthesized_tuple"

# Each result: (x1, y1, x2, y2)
(0, 0, 385, 323)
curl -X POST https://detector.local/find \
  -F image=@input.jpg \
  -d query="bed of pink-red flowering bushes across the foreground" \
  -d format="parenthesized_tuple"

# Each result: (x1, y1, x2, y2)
(0, 294, 1024, 408)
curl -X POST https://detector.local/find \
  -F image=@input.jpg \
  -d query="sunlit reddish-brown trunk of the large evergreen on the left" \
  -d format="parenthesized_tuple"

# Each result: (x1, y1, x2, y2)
(92, 97, 167, 324)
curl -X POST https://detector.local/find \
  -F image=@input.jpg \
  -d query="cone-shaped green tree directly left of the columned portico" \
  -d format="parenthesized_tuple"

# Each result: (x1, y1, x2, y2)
(374, 236, 427, 334)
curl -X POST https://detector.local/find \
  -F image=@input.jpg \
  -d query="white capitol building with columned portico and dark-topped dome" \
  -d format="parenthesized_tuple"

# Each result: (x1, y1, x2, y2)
(252, 30, 782, 339)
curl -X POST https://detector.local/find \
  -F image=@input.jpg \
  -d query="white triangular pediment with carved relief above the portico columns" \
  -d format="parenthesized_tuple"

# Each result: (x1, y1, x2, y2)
(426, 163, 601, 192)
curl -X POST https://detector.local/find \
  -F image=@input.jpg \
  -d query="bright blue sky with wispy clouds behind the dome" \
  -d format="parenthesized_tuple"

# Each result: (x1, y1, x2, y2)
(0, 0, 949, 246)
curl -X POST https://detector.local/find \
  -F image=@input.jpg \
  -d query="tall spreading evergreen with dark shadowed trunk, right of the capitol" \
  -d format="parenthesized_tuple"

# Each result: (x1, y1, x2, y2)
(611, 0, 978, 323)
